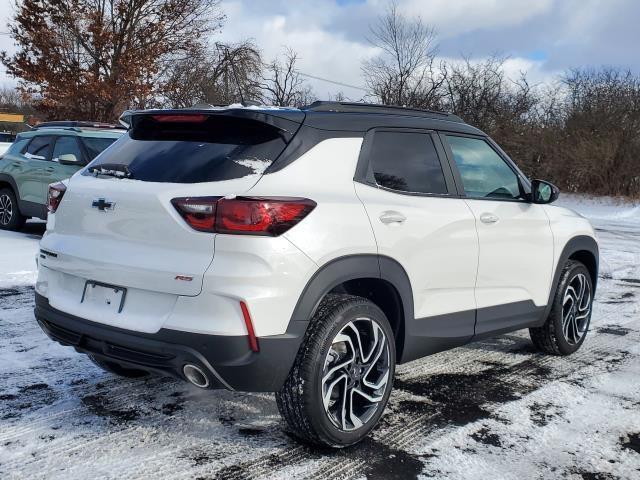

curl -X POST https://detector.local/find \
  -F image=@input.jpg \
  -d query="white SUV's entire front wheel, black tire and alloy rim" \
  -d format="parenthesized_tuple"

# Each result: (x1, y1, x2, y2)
(529, 260, 593, 355)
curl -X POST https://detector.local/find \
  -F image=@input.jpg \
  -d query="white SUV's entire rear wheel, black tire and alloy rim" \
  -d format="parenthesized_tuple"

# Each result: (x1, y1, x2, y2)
(276, 294, 396, 448)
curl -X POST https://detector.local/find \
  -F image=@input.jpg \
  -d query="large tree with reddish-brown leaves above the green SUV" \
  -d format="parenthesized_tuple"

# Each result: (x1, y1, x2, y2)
(0, 0, 224, 121)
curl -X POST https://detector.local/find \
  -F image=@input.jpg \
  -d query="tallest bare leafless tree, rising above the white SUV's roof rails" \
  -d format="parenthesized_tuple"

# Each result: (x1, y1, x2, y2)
(362, 1, 444, 108)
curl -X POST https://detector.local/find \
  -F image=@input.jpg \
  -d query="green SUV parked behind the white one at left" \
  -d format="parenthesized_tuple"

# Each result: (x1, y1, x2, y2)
(0, 122, 125, 230)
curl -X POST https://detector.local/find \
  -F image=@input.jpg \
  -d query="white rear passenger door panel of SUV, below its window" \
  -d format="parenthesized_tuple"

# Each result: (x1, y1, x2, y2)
(356, 184, 478, 319)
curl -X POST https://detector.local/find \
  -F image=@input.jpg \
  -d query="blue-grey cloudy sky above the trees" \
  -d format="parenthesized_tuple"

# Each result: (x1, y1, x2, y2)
(0, 0, 640, 99)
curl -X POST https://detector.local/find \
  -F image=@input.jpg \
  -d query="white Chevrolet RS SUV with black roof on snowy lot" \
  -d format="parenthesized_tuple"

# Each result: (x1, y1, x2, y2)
(35, 102, 598, 446)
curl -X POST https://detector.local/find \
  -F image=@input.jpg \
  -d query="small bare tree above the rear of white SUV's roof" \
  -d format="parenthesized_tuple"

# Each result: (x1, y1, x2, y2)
(259, 47, 314, 107)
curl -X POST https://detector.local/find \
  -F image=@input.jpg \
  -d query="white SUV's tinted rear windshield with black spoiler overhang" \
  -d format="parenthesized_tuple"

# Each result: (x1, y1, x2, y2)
(84, 115, 286, 183)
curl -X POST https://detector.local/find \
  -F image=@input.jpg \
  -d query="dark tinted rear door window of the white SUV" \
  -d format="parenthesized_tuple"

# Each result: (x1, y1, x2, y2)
(370, 131, 447, 194)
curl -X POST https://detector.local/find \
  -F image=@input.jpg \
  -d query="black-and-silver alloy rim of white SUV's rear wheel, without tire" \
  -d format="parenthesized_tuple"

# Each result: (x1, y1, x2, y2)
(321, 317, 390, 431)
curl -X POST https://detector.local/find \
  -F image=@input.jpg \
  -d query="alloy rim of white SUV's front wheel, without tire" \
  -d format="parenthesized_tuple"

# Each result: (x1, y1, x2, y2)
(562, 273, 591, 345)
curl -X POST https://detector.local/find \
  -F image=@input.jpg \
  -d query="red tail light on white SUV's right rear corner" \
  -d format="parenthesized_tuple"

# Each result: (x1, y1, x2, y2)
(171, 197, 316, 237)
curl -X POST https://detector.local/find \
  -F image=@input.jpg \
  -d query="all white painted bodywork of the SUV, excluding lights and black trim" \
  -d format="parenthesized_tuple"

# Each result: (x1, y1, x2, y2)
(37, 120, 593, 342)
